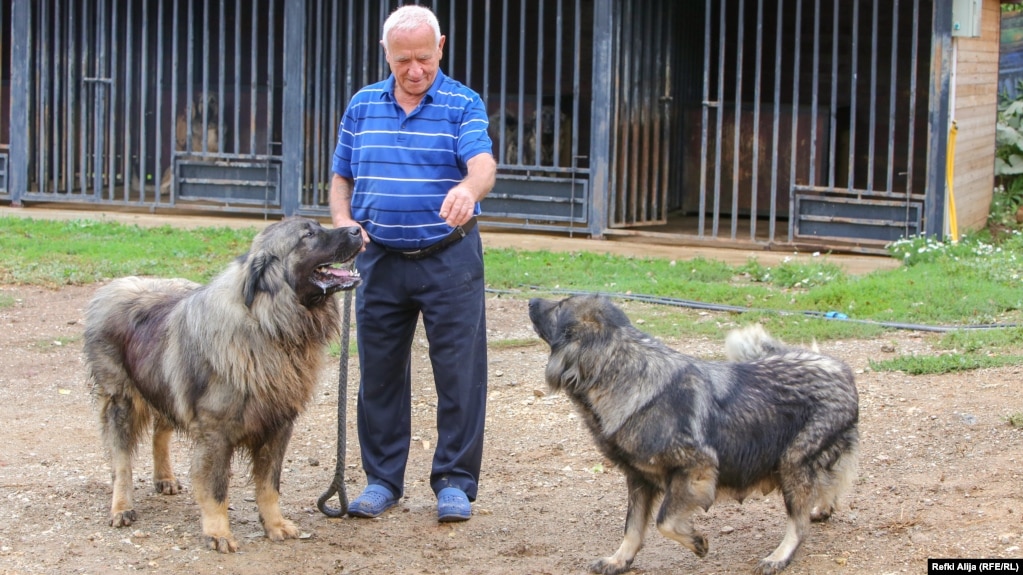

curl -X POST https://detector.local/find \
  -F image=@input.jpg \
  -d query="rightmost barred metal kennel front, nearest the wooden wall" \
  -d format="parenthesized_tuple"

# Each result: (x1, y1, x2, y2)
(679, 0, 933, 245)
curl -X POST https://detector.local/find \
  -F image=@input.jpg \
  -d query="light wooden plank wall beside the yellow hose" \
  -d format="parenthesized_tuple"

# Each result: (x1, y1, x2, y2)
(952, 0, 1002, 233)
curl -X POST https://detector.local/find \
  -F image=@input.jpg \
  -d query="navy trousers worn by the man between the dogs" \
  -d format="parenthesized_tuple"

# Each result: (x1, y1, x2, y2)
(355, 229, 487, 500)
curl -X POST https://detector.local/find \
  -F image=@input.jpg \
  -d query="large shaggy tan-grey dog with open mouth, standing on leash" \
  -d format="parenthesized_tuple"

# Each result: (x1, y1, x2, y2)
(84, 218, 362, 552)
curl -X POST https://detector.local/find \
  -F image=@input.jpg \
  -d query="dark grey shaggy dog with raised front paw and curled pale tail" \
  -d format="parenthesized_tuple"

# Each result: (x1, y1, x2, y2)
(529, 296, 859, 575)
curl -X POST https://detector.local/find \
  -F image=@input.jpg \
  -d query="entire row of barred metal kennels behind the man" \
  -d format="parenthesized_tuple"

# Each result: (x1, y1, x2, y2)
(0, 0, 940, 245)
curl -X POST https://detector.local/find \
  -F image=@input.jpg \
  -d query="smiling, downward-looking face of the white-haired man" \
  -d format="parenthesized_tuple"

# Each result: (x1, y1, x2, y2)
(384, 26, 445, 97)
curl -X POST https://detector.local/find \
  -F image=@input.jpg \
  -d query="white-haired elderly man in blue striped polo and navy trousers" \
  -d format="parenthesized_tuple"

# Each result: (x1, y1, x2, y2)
(330, 5, 496, 522)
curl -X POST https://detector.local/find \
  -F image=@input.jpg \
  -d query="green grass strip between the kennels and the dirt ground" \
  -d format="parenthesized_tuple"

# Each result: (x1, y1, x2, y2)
(6, 212, 1023, 372)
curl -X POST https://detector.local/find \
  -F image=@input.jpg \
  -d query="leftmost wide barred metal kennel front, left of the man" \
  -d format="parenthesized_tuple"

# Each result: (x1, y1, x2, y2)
(14, 0, 283, 213)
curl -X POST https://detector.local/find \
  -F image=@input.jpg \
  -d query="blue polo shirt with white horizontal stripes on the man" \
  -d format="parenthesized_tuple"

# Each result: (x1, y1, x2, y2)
(333, 69, 492, 250)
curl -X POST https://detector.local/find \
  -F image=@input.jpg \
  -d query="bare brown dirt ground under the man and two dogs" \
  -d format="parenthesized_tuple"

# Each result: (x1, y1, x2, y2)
(0, 285, 1023, 575)
